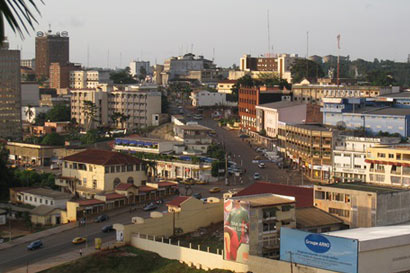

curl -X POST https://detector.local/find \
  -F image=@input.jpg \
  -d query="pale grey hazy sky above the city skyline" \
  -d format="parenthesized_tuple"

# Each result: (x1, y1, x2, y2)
(6, 0, 410, 67)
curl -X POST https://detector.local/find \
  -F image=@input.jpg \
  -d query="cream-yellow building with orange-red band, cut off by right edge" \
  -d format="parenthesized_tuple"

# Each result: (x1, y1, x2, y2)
(366, 145, 410, 188)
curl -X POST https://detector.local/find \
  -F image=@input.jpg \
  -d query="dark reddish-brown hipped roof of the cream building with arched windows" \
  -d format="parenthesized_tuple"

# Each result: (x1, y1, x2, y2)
(64, 149, 142, 166)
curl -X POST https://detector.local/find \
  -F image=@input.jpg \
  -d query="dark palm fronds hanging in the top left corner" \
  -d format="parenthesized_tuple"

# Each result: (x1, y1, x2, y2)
(0, 0, 44, 45)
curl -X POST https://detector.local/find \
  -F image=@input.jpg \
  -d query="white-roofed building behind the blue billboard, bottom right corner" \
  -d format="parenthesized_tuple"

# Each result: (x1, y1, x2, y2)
(328, 225, 410, 273)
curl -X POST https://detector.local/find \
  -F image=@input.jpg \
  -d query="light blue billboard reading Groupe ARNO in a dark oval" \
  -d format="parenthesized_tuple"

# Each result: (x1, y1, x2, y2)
(280, 227, 358, 273)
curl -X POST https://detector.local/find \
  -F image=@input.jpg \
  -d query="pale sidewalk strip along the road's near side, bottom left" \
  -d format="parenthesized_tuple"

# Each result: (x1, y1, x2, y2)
(9, 241, 116, 273)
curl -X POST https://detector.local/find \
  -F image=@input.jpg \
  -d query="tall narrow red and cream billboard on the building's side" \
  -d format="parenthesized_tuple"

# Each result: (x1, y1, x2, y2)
(224, 199, 250, 263)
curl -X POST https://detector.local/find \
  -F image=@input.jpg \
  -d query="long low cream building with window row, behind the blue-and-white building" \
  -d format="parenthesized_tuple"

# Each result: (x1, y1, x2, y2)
(292, 81, 400, 104)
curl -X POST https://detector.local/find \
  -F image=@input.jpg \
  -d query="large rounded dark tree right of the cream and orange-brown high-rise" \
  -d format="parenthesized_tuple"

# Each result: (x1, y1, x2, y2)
(290, 59, 325, 83)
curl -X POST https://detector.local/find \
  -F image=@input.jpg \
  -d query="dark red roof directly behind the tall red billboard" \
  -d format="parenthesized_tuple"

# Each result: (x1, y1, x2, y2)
(234, 182, 313, 208)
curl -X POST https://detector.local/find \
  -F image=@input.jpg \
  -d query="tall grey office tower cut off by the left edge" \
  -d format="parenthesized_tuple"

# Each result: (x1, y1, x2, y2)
(0, 38, 22, 140)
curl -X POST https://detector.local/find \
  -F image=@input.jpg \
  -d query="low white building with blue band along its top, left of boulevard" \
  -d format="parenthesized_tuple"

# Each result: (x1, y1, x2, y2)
(114, 136, 182, 154)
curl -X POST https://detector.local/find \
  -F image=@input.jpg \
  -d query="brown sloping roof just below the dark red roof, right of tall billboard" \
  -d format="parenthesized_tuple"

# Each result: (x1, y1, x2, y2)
(296, 207, 343, 228)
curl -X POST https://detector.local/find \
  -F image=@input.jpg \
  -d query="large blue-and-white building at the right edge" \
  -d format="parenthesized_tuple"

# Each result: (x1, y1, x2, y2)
(321, 98, 410, 137)
